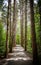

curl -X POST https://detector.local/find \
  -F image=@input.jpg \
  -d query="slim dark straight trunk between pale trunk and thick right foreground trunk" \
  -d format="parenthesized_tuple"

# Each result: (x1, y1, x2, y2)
(25, 0, 27, 51)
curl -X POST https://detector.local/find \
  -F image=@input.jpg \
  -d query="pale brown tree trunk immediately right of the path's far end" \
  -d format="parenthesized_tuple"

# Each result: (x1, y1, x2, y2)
(20, 0, 24, 46)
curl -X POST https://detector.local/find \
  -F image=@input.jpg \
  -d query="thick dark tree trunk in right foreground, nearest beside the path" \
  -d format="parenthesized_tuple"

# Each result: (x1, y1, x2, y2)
(30, 0, 38, 63)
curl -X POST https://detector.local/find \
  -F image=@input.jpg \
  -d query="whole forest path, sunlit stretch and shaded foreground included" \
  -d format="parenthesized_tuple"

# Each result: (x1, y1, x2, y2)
(0, 45, 32, 65)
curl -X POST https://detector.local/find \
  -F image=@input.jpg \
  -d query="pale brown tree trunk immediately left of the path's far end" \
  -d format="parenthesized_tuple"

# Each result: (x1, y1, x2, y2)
(12, 0, 16, 46)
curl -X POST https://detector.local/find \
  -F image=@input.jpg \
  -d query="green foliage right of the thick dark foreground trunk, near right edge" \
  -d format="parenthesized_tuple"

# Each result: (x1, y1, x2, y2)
(34, 6, 41, 52)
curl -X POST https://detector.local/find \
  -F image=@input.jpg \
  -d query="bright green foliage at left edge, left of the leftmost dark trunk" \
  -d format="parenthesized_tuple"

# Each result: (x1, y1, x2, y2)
(0, 22, 5, 56)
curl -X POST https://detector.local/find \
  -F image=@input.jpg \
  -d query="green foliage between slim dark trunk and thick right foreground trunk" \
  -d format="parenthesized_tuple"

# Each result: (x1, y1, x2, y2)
(27, 25, 32, 53)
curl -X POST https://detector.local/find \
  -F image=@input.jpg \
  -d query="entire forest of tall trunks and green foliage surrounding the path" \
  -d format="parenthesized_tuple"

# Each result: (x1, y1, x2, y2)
(0, 0, 41, 62)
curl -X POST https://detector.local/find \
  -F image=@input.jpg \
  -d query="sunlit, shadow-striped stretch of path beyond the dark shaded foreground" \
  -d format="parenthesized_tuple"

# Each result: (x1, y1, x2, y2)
(6, 45, 32, 61)
